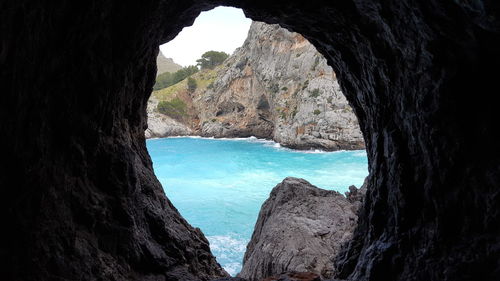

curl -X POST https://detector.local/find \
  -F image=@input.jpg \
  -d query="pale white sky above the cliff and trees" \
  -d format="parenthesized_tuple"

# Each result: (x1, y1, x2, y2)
(160, 7, 252, 66)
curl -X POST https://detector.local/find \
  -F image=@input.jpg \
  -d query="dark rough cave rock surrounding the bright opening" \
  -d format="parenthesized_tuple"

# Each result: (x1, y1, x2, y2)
(0, 0, 500, 280)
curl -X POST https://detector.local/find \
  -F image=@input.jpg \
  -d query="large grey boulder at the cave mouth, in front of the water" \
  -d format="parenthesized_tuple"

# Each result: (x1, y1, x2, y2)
(238, 178, 366, 281)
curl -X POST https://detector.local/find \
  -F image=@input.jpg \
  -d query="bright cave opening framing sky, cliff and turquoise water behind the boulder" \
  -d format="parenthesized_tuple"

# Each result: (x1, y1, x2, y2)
(146, 7, 367, 275)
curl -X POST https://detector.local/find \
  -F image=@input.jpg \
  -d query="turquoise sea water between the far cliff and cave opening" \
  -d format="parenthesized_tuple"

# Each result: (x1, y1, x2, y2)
(147, 138, 368, 275)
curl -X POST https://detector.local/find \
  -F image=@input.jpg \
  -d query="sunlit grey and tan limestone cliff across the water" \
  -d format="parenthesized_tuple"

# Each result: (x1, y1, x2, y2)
(150, 22, 364, 150)
